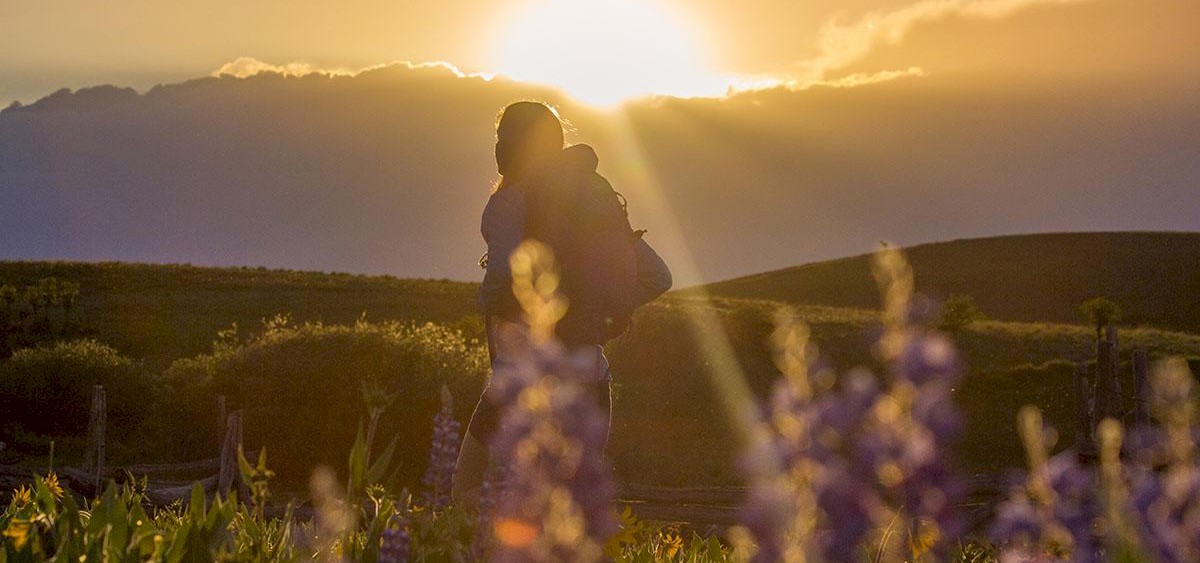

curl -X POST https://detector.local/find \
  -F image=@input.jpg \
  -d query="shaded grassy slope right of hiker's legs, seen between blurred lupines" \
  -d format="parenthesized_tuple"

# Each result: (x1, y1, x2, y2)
(608, 297, 1200, 485)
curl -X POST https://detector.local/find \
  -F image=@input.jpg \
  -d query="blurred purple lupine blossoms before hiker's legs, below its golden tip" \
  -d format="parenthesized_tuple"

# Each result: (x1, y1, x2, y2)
(491, 343, 617, 561)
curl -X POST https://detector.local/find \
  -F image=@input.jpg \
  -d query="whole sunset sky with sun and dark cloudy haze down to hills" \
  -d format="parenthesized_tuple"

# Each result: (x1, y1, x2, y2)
(0, 0, 1200, 280)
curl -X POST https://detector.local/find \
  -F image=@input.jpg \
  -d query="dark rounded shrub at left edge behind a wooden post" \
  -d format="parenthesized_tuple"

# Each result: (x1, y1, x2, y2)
(0, 340, 161, 439)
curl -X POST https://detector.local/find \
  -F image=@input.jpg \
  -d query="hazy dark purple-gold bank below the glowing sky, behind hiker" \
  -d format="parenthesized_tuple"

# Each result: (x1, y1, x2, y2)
(0, 64, 1200, 286)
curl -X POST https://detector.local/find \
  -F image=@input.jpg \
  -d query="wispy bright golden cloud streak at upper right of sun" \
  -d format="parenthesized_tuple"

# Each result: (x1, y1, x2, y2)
(798, 0, 1090, 83)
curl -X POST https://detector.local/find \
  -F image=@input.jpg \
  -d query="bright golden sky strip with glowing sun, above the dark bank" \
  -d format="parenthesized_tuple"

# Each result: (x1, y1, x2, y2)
(0, 0, 1200, 102)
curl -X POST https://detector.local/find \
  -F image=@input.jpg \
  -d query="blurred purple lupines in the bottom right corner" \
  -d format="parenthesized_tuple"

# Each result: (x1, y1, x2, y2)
(992, 360, 1200, 562)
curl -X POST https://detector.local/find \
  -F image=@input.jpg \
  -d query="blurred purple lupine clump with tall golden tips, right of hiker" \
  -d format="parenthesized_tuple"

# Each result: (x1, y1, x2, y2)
(743, 248, 965, 562)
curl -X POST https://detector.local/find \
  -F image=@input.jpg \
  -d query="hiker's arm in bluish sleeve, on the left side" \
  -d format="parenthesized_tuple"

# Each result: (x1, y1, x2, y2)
(479, 188, 524, 318)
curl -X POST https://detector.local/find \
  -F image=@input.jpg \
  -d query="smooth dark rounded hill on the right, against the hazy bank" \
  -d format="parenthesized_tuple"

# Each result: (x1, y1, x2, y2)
(691, 233, 1200, 333)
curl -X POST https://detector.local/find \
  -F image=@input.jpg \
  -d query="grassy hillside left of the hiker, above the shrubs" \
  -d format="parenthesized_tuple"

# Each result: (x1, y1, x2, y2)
(0, 262, 475, 367)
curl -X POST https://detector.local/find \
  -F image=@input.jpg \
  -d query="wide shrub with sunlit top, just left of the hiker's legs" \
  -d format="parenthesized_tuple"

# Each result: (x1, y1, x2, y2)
(164, 319, 487, 484)
